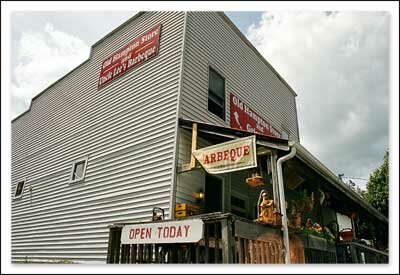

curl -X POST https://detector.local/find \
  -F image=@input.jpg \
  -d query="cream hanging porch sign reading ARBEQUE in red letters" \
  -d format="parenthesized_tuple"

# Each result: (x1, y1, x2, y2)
(192, 136, 257, 174)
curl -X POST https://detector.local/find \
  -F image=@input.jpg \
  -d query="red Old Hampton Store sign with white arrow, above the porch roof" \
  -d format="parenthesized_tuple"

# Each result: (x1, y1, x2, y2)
(230, 93, 282, 138)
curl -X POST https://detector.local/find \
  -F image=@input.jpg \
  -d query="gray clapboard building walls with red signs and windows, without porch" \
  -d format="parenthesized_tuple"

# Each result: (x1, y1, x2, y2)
(11, 12, 388, 263)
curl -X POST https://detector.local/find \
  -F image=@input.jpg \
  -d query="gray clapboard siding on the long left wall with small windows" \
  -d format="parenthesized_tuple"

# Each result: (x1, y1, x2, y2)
(11, 12, 184, 263)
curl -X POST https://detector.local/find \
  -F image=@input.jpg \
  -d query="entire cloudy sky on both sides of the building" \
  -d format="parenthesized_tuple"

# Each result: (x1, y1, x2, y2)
(10, 11, 390, 192)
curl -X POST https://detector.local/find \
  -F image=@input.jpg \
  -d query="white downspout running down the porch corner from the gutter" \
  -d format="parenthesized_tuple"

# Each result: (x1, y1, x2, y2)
(276, 143, 296, 264)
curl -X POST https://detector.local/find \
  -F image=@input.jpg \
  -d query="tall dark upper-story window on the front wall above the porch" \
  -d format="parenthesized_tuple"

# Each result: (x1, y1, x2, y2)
(208, 68, 225, 120)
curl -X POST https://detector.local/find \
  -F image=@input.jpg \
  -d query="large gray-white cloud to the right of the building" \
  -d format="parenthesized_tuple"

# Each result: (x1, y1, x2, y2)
(248, 11, 390, 191)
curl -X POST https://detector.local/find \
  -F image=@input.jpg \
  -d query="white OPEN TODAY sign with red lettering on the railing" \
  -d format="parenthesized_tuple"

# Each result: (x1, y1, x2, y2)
(121, 219, 203, 244)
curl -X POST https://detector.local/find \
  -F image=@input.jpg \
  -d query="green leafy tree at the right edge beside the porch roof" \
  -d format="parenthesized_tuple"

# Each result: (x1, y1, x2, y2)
(365, 150, 389, 217)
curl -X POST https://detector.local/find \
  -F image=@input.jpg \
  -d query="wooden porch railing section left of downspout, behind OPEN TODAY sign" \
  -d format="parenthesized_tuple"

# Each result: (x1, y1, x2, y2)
(107, 213, 283, 264)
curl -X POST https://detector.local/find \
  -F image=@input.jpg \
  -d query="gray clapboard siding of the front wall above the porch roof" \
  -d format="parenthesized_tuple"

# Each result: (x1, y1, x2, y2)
(180, 12, 298, 140)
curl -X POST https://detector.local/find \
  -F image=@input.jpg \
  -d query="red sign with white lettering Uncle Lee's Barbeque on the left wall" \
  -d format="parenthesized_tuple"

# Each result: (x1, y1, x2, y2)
(97, 25, 161, 88)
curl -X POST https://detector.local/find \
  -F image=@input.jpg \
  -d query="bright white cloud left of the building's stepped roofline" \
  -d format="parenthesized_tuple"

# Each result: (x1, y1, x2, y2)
(11, 23, 90, 117)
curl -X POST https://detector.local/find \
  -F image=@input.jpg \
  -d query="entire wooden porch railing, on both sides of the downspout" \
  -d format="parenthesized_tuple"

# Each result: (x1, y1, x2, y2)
(107, 213, 388, 264)
